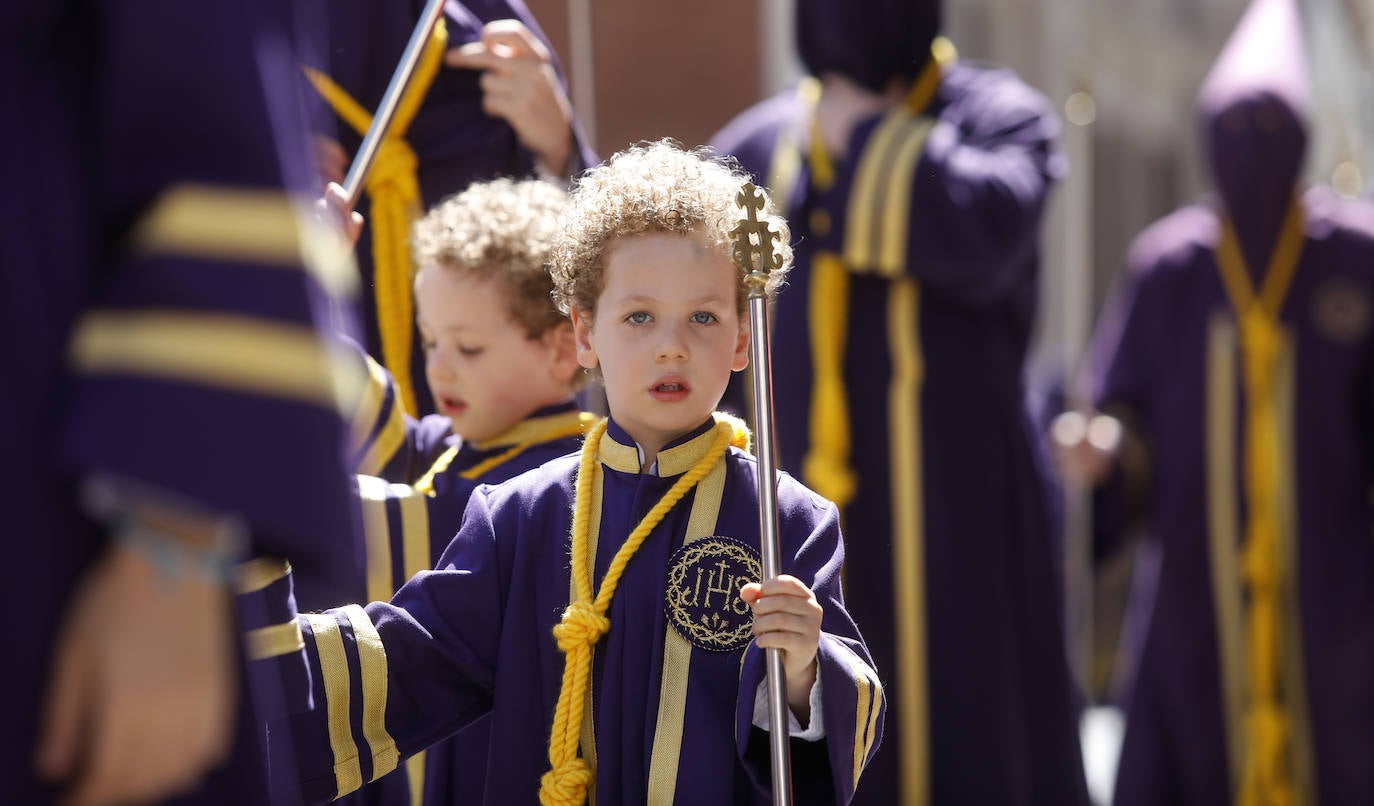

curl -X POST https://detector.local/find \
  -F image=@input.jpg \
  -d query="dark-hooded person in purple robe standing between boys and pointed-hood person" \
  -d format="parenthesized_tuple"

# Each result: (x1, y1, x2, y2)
(713, 0, 1087, 805)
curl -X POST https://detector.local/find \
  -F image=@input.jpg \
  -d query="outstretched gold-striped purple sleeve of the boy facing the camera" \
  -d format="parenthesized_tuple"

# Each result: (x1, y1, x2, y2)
(269, 490, 506, 803)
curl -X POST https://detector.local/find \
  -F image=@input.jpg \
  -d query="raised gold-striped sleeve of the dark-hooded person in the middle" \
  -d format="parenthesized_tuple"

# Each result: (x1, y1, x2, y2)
(844, 65, 1063, 303)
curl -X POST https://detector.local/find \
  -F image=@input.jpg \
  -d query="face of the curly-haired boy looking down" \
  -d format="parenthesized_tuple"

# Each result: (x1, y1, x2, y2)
(415, 266, 578, 442)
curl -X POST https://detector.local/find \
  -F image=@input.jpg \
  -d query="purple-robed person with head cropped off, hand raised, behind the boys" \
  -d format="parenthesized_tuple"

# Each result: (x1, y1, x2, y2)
(303, 0, 596, 416)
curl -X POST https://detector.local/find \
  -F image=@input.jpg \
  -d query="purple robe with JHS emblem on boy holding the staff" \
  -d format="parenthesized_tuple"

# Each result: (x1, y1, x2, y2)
(273, 423, 883, 805)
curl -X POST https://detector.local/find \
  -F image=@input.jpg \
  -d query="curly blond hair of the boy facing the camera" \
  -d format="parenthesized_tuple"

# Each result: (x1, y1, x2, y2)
(550, 140, 791, 320)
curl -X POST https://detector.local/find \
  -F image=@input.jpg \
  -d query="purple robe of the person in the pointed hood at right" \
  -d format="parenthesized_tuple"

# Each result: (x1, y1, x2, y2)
(1094, 189, 1374, 803)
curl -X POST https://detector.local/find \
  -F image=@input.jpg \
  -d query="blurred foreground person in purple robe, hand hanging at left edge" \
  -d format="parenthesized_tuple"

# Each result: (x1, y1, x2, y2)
(0, 0, 356, 803)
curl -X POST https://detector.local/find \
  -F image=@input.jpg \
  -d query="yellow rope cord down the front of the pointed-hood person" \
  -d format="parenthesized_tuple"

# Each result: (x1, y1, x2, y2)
(1216, 198, 1304, 806)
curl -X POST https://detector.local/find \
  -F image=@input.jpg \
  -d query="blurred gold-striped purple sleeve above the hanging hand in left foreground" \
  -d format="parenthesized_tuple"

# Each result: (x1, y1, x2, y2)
(60, 0, 357, 587)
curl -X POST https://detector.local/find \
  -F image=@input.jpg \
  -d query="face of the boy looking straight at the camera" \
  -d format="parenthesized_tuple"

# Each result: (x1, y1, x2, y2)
(573, 233, 749, 454)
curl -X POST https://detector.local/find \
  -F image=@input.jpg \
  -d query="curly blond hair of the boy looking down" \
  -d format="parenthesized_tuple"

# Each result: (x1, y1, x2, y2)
(412, 179, 567, 339)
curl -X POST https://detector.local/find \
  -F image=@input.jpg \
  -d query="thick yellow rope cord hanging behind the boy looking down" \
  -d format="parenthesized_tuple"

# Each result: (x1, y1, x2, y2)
(305, 19, 448, 415)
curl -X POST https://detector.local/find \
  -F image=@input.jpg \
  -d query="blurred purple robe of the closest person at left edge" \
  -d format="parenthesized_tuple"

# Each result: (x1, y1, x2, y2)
(0, 0, 356, 803)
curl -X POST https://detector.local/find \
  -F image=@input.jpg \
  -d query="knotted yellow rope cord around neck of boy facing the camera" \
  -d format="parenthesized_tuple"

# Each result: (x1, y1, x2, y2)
(539, 419, 747, 806)
